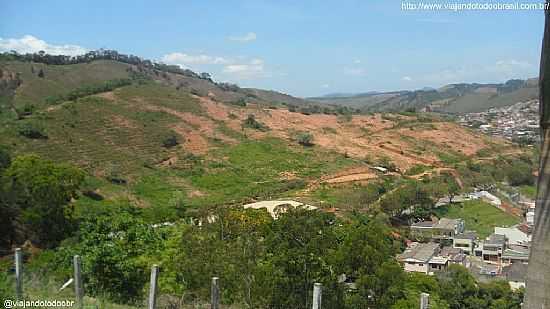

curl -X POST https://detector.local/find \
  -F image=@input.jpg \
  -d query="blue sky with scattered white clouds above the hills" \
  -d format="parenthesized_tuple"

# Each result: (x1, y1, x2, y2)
(0, 0, 544, 96)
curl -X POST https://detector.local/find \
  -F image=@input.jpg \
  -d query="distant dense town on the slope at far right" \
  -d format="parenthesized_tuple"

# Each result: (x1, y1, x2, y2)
(458, 100, 540, 145)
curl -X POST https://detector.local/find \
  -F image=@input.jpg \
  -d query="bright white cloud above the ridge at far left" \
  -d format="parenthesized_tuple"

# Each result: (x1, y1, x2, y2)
(0, 35, 87, 56)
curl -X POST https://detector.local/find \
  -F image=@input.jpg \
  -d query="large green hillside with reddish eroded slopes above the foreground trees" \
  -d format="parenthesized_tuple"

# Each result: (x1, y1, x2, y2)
(0, 61, 532, 217)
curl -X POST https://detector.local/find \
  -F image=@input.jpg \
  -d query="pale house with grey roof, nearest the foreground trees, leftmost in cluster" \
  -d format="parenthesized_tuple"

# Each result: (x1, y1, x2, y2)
(397, 242, 447, 274)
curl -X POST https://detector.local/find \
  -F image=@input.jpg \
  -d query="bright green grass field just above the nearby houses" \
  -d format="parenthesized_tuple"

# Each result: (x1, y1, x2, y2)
(436, 200, 520, 238)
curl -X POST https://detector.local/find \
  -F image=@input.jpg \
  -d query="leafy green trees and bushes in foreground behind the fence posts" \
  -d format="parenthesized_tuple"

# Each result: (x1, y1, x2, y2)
(0, 208, 523, 309)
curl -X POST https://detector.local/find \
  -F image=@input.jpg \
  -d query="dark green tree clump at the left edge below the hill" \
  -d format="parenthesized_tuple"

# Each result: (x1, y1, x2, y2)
(0, 156, 84, 248)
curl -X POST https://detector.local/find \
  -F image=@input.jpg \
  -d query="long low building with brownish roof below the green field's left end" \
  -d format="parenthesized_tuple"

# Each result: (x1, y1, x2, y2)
(411, 218, 464, 242)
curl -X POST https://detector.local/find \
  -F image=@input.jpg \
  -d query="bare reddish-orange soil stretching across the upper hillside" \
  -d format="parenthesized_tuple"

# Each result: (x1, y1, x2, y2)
(191, 97, 516, 170)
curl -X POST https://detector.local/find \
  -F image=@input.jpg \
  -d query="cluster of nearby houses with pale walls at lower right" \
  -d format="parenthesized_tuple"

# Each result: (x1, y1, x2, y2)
(397, 186, 535, 289)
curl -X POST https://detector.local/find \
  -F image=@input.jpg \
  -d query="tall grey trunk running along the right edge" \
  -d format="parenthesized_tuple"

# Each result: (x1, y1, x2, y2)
(524, 0, 550, 309)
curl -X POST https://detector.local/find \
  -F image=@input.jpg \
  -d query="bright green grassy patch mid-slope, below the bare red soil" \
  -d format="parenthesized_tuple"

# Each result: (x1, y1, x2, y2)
(186, 138, 353, 205)
